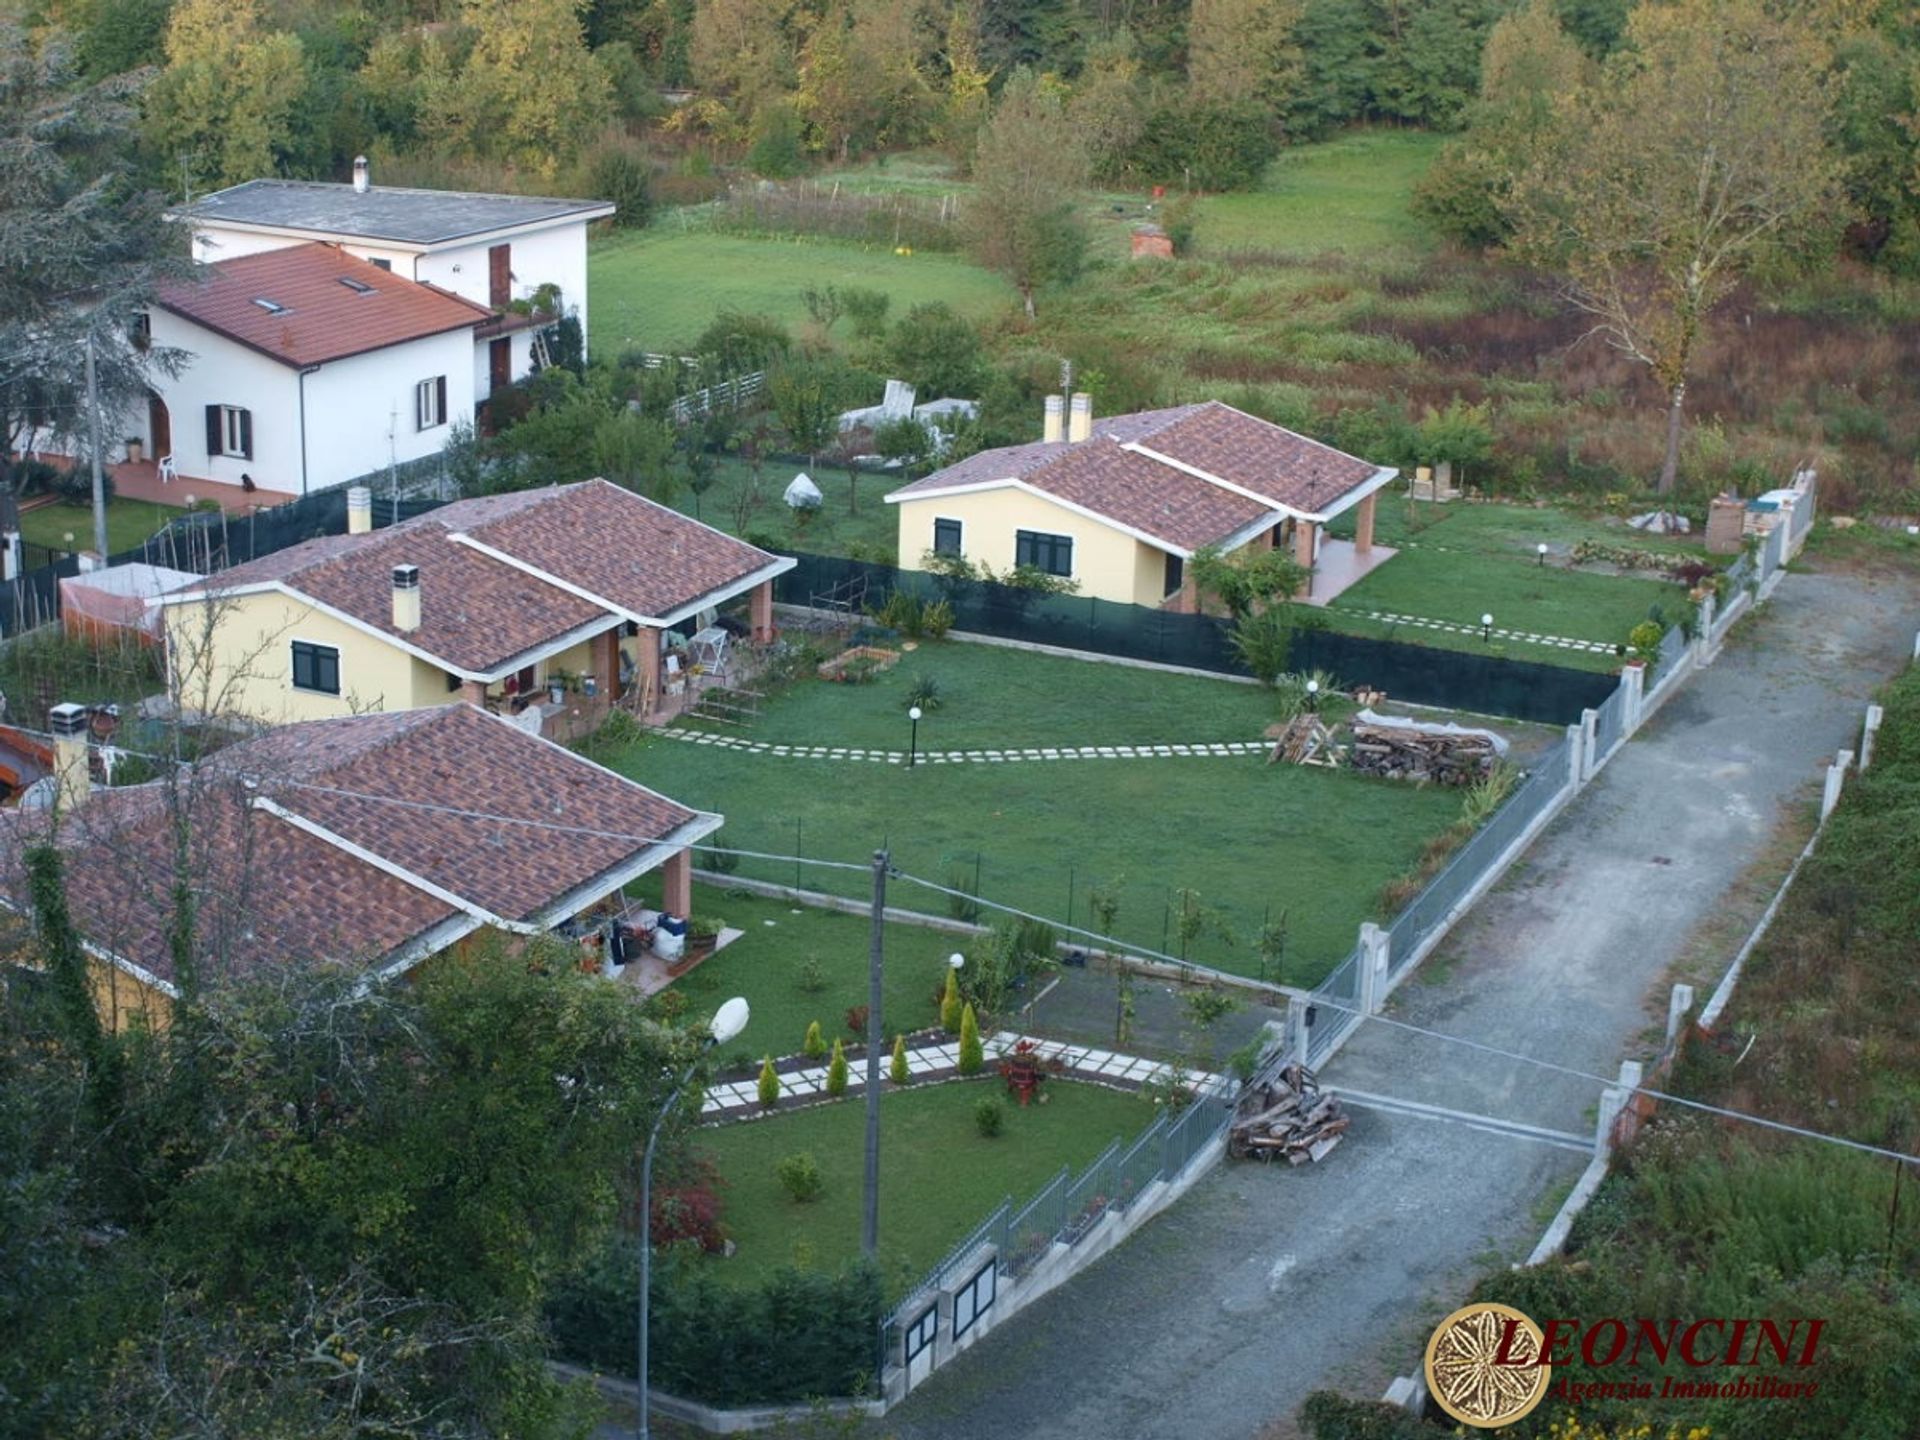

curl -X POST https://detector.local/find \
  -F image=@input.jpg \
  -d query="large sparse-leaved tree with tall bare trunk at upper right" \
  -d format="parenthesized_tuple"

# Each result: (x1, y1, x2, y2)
(1513, 0, 1839, 493)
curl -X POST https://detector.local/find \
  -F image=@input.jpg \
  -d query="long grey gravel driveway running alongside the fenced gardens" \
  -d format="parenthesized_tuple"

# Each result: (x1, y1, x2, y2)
(876, 572, 1920, 1440)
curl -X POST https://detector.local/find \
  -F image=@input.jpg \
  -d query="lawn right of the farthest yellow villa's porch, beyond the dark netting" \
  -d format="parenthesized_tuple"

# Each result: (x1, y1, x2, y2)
(1329, 547, 1690, 662)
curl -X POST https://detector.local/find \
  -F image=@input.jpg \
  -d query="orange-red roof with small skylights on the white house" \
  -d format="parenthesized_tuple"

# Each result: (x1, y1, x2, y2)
(156, 244, 492, 367)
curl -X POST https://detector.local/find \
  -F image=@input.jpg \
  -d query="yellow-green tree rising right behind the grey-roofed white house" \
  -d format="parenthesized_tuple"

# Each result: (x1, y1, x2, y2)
(457, 0, 612, 177)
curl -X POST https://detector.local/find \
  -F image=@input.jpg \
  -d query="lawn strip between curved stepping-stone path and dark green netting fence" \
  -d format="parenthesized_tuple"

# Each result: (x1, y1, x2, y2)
(695, 639, 1277, 753)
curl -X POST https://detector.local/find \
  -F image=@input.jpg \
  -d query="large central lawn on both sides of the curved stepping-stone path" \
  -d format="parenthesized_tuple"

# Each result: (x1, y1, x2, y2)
(599, 641, 1461, 990)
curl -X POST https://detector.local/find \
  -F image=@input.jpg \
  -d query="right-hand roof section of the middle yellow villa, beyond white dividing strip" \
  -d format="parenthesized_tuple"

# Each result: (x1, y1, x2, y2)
(456, 480, 793, 620)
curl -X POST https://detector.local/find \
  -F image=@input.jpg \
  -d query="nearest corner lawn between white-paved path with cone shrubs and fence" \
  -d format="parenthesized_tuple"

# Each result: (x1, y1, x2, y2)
(695, 1077, 1154, 1298)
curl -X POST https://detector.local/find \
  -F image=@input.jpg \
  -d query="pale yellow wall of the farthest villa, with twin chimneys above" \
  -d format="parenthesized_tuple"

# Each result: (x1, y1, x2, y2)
(895, 490, 1165, 605)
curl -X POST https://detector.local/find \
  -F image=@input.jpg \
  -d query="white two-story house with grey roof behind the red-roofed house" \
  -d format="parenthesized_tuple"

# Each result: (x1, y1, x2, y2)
(177, 159, 614, 414)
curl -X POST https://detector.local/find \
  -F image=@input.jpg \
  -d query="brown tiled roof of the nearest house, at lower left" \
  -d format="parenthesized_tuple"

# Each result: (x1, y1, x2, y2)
(0, 705, 701, 979)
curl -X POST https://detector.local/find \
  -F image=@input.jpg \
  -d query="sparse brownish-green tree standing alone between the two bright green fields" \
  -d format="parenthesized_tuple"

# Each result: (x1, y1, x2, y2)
(968, 69, 1091, 319)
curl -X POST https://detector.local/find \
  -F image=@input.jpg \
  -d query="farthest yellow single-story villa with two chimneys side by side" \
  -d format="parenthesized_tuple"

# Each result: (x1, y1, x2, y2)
(887, 394, 1400, 611)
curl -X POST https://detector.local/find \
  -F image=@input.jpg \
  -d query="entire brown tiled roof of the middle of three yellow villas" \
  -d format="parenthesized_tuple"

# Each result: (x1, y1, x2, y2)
(180, 480, 791, 674)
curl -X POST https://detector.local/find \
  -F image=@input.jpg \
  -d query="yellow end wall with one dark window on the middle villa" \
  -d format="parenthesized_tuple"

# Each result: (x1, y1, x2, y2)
(167, 593, 453, 724)
